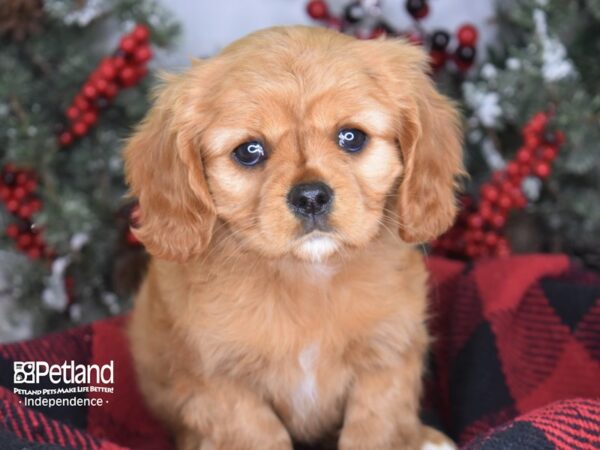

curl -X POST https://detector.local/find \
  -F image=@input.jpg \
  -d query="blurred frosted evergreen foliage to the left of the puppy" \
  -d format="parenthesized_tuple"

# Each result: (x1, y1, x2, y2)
(0, 0, 178, 340)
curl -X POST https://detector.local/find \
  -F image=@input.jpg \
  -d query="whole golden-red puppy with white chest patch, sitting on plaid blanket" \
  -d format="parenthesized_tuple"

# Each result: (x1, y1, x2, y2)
(125, 27, 463, 450)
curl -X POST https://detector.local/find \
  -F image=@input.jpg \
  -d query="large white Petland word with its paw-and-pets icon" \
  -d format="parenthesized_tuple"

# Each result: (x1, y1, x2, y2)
(13, 361, 114, 385)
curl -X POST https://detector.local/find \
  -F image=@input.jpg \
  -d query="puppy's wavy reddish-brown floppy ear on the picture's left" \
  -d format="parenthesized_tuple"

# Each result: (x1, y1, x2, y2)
(124, 77, 216, 261)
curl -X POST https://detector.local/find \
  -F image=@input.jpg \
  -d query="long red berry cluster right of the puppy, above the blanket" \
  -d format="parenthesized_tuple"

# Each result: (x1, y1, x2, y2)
(433, 112, 565, 258)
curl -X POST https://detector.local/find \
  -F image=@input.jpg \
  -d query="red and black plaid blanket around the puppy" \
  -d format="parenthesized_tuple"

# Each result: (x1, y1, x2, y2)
(0, 255, 600, 450)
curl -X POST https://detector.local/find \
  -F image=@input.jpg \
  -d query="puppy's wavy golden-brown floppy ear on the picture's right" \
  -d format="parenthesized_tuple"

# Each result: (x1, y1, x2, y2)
(380, 41, 465, 243)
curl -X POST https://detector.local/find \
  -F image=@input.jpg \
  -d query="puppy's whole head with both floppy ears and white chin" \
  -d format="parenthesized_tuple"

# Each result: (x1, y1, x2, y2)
(126, 27, 462, 261)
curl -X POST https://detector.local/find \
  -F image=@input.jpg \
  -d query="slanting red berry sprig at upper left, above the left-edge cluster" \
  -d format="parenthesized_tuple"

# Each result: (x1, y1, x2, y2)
(58, 25, 152, 147)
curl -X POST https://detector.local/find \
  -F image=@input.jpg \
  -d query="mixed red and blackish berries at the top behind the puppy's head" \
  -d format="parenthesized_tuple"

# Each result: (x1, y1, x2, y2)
(306, 0, 478, 72)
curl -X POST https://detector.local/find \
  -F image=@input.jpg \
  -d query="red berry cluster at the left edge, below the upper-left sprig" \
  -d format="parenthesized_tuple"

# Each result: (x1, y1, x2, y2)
(0, 164, 52, 259)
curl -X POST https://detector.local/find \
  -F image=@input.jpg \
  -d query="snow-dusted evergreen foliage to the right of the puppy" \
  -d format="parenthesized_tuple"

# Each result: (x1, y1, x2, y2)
(465, 0, 600, 267)
